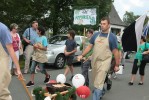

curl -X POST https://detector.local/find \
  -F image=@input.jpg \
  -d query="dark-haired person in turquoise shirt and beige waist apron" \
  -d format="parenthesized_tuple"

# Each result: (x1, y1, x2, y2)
(26, 27, 50, 87)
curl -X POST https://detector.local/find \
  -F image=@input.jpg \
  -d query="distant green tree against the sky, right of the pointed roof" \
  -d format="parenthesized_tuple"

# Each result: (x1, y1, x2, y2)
(123, 11, 139, 25)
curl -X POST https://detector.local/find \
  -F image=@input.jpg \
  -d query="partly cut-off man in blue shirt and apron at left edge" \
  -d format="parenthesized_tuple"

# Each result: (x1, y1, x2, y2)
(0, 22, 22, 100)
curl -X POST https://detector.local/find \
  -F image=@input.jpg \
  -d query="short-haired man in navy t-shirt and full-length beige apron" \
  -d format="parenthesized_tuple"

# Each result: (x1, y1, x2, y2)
(78, 17, 120, 100)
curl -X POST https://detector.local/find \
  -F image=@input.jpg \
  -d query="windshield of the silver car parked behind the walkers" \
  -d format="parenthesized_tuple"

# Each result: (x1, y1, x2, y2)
(49, 36, 67, 45)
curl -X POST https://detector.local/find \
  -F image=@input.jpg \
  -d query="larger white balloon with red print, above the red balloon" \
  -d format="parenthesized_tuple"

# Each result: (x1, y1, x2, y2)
(72, 74, 85, 88)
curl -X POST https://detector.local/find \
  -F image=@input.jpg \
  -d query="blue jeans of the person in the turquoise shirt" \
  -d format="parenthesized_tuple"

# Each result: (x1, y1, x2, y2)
(30, 60, 46, 74)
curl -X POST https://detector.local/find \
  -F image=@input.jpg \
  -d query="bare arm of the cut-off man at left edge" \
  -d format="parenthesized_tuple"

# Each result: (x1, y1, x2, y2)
(6, 44, 22, 78)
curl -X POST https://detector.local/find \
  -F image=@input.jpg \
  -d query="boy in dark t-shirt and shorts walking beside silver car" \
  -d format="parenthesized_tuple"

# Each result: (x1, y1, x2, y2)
(64, 30, 77, 80)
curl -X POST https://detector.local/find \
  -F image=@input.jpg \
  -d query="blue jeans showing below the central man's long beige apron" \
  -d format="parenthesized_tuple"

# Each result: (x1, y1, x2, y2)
(93, 88, 105, 100)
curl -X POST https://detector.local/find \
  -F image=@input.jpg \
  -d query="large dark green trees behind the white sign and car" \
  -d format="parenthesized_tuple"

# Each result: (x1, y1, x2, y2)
(0, 0, 113, 35)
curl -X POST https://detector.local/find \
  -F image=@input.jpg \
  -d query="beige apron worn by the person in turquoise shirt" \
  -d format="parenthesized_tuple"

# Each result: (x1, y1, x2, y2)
(32, 43, 48, 63)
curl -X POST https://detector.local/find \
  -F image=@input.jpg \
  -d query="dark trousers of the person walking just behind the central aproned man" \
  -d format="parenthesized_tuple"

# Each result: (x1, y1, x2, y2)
(81, 60, 91, 86)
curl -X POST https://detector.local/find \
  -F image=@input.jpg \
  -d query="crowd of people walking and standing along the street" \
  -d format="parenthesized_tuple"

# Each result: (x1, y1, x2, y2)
(0, 17, 149, 100)
